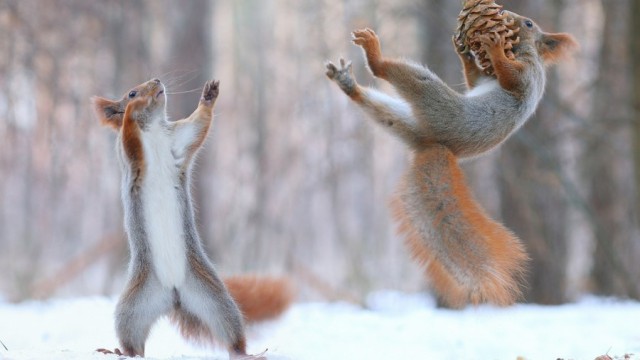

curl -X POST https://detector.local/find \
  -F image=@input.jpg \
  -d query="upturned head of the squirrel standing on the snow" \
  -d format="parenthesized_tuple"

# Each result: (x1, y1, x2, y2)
(91, 79, 166, 131)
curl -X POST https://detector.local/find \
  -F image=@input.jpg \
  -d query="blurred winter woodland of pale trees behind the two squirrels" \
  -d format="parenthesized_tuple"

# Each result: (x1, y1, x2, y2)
(0, 0, 640, 304)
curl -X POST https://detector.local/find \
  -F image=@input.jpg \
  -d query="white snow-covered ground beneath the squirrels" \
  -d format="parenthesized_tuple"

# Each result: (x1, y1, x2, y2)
(0, 292, 640, 360)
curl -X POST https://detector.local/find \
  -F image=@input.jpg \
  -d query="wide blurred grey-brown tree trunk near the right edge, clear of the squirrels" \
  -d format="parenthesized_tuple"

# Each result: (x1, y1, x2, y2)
(585, 0, 639, 298)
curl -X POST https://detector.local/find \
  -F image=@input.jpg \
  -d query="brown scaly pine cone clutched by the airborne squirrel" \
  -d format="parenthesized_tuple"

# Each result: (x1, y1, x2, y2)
(455, 0, 520, 76)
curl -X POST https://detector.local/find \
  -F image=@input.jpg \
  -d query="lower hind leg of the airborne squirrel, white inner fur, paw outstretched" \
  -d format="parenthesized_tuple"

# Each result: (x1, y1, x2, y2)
(326, 59, 420, 147)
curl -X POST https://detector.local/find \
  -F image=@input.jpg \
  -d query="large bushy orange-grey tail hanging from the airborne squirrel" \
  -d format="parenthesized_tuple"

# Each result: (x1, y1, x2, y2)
(391, 144, 529, 307)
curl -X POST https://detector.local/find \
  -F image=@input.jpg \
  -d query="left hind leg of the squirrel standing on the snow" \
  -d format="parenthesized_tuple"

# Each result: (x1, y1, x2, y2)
(116, 268, 173, 357)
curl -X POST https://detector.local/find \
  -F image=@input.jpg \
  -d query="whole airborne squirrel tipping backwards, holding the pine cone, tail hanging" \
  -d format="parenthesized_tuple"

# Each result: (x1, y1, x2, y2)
(326, 12, 577, 307)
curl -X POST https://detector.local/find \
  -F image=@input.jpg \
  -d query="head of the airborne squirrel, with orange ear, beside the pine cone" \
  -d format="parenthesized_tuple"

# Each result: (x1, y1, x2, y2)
(505, 11, 578, 65)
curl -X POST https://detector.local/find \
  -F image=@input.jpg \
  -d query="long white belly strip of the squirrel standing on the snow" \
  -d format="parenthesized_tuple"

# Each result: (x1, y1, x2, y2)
(142, 129, 187, 288)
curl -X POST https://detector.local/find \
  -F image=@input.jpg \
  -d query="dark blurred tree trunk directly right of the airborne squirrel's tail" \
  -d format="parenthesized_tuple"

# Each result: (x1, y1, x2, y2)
(500, 0, 568, 304)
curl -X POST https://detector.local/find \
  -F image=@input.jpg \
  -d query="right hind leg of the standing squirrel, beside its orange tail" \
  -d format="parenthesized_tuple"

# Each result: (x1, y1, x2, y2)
(172, 252, 254, 358)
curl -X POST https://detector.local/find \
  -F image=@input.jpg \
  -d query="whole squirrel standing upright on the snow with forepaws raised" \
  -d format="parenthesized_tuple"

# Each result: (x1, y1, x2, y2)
(93, 79, 292, 358)
